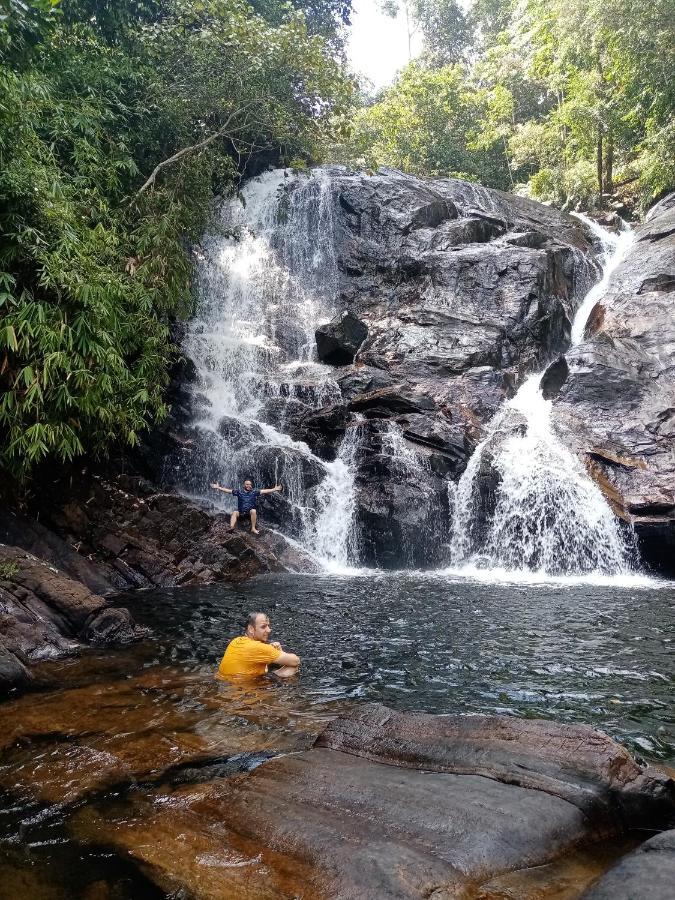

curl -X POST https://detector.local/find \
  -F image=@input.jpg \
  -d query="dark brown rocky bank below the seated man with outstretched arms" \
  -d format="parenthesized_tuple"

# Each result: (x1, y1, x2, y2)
(0, 476, 310, 593)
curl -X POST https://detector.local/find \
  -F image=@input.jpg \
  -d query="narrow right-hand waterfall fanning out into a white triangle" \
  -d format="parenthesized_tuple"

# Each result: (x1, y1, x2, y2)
(451, 217, 632, 575)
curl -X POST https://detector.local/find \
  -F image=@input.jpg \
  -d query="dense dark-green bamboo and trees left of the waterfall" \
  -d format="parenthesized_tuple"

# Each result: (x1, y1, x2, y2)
(0, 0, 351, 476)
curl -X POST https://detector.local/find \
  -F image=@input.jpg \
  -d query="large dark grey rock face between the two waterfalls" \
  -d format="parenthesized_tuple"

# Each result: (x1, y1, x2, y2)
(291, 168, 598, 567)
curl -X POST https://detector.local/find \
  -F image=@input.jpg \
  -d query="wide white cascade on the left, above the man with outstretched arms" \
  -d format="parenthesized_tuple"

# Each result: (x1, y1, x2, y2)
(174, 171, 358, 565)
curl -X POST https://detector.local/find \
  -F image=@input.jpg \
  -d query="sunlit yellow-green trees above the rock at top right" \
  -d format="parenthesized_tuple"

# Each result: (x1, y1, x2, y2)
(345, 0, 675, 208)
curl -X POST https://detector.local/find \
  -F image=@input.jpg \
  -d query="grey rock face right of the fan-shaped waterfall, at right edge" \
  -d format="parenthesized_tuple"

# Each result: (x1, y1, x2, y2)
(555, 195, 675, 573)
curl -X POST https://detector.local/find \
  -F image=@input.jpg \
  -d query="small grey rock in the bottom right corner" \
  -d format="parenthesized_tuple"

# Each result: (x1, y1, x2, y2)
(583, 831, 675, 900)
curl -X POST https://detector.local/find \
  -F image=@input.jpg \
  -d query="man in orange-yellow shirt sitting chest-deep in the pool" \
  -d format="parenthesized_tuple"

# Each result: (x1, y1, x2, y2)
(218, 613, 300, 678)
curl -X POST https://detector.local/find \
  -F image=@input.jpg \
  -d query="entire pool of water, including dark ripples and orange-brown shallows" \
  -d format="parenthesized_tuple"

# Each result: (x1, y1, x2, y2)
(0, 574, 675, 900)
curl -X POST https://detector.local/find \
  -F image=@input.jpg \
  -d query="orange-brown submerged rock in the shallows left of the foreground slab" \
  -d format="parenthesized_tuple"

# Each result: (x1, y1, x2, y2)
(0, 664, 325, 804)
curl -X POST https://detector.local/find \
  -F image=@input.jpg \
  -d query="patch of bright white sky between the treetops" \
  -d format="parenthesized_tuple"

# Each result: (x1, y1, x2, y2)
(347, 0, 419, 88)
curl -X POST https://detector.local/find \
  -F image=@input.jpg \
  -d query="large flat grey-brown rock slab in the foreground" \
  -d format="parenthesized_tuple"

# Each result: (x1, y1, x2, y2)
(78, 705, 675, 900)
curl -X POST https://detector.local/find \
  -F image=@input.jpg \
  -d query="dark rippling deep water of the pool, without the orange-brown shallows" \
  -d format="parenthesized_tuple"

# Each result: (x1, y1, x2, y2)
(133, 575, 675, 763)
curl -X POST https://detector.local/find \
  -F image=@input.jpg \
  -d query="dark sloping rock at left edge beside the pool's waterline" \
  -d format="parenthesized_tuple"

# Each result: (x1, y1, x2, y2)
(0, 544, 145, 691)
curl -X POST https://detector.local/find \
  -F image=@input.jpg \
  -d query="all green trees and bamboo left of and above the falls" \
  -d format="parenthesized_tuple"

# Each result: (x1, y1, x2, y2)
(0, 0, 675, 478)
